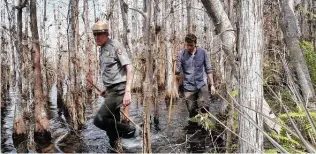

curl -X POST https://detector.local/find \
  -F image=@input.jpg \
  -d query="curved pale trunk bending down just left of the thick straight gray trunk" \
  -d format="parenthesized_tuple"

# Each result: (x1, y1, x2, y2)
(201, 0, 237, 152)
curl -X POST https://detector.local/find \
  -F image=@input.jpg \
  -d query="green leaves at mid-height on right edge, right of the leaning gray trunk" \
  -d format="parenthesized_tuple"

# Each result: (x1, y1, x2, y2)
(299, 41, 316, 88)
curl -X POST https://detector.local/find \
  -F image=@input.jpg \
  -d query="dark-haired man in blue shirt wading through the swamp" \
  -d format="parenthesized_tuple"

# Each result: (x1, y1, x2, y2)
(176, 34, 215, 122)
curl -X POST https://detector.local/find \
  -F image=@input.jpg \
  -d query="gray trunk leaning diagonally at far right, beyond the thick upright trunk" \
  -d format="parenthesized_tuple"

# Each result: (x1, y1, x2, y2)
(280, 0, 315, 102)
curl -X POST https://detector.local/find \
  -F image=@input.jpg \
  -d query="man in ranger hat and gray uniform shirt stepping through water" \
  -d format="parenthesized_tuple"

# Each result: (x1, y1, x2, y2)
(92, 21, 138, 152)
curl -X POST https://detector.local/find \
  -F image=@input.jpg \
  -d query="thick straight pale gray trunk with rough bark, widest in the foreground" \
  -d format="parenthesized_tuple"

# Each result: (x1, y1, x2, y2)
(238, 0, 264, 153)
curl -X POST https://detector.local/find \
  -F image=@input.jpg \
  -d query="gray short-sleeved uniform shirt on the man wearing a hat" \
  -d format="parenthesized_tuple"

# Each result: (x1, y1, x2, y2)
(100, 39, 131, 87)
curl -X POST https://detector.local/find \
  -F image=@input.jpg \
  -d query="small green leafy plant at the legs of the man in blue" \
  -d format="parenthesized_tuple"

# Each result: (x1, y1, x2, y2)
(190, 113, 215, 131)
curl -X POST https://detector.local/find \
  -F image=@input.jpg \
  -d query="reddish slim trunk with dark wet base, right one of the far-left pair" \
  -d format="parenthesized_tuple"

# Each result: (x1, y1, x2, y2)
(30, 0, 51, 143)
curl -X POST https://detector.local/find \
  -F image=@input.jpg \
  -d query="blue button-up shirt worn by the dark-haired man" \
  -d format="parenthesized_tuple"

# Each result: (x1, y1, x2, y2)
(176, 47, 212, 91)
